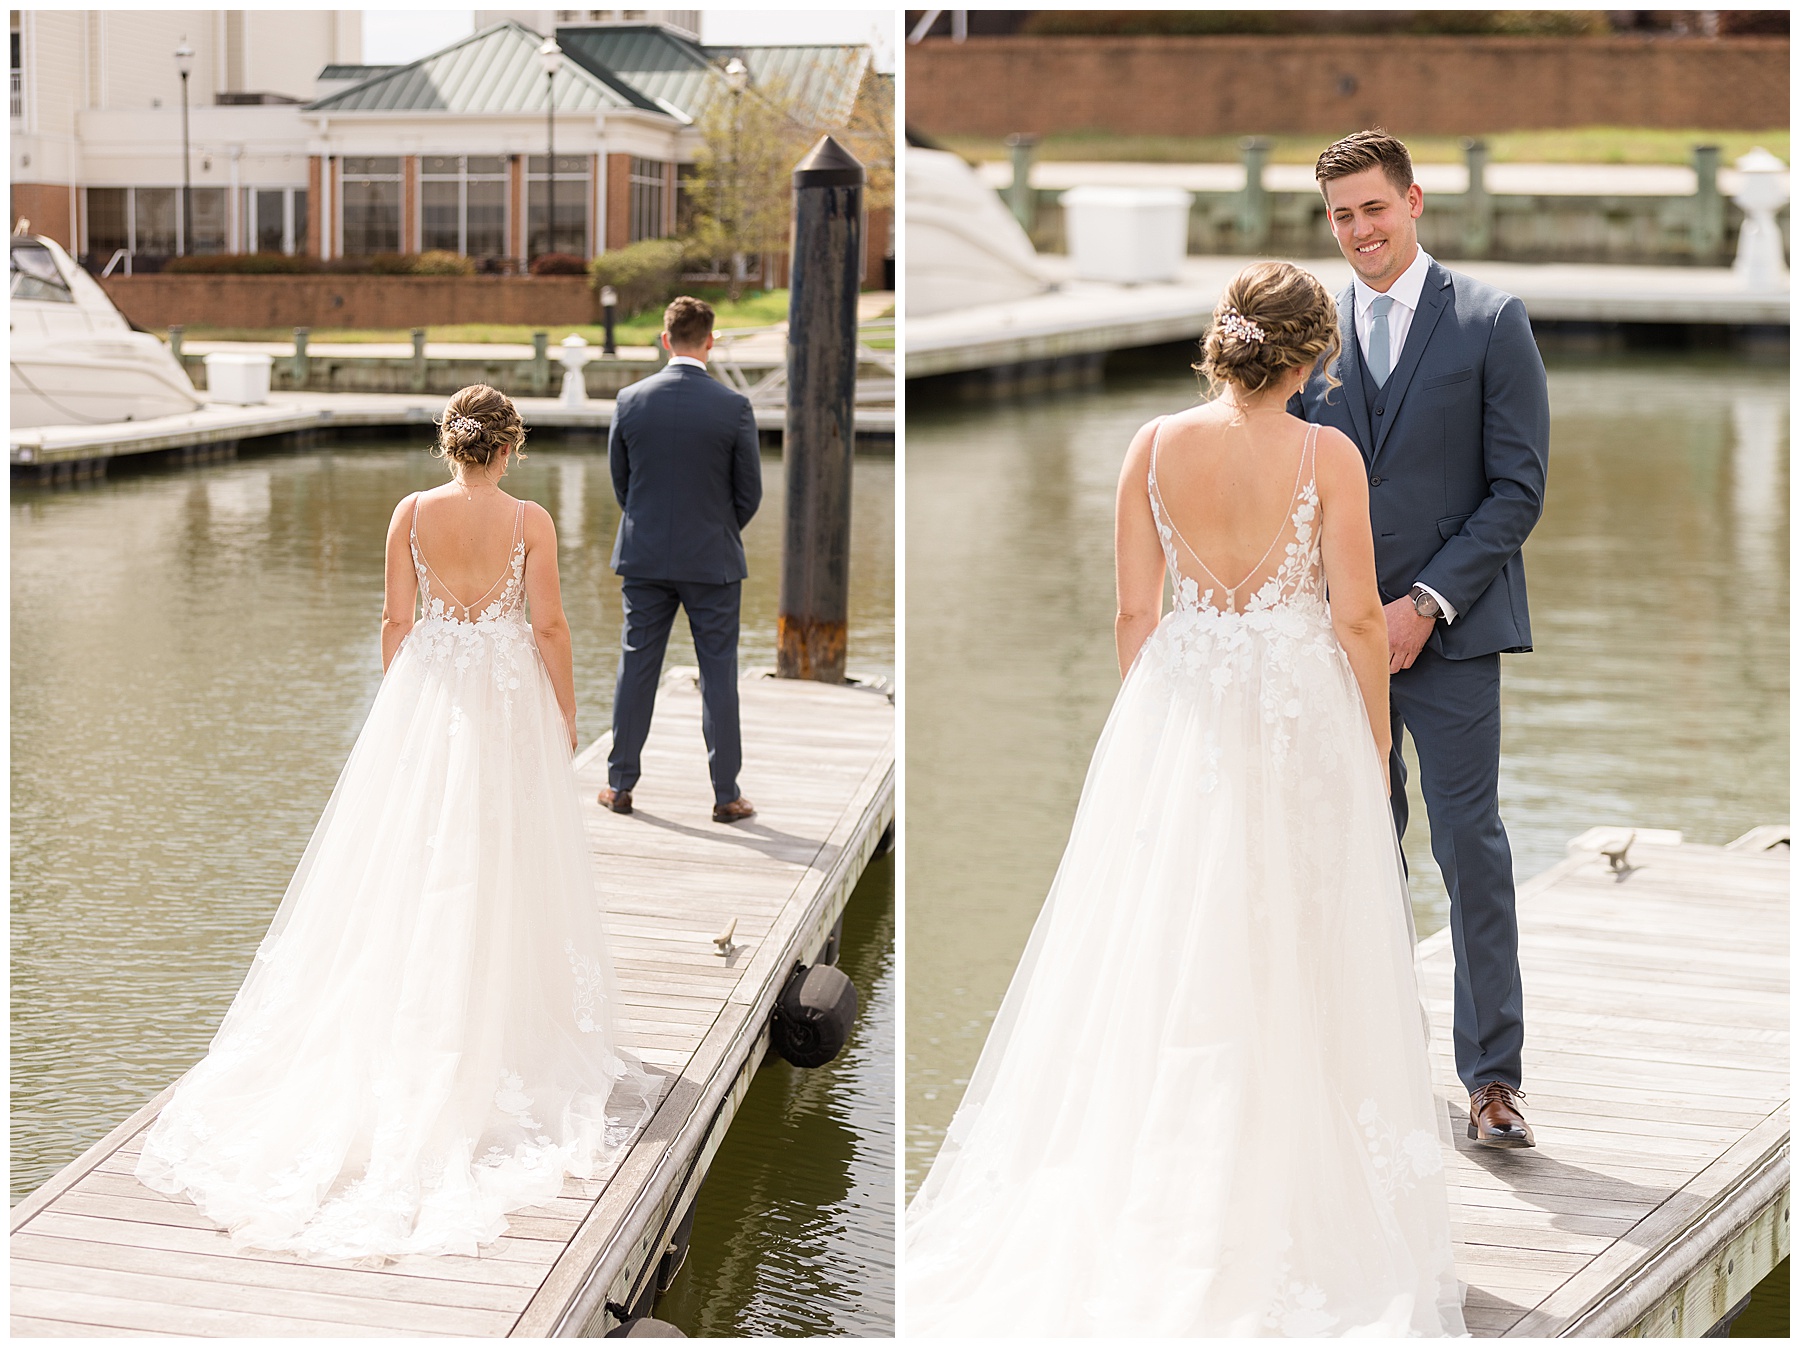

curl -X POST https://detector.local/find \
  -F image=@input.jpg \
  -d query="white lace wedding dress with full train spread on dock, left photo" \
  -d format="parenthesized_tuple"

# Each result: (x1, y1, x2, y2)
(137, 502, 661, 1258)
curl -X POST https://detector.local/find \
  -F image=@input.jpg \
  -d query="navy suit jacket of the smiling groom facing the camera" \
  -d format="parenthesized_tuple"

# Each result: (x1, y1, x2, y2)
(1300, 261, 1550, 661)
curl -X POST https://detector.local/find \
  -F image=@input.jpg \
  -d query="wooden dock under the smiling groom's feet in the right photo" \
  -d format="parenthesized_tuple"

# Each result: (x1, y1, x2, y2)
(1440, 828, 1789, 1339)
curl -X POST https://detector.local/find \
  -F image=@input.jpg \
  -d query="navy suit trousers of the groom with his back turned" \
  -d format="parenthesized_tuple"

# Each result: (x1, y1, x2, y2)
(607, 576, 743, 804)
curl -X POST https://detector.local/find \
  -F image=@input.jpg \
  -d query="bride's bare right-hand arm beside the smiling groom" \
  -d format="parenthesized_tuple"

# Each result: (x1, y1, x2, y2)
(1316, 427, 1393, 788)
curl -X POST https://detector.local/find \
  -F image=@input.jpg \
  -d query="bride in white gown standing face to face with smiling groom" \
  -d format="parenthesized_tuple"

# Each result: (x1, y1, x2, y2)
(904, 263, 1463, 1337)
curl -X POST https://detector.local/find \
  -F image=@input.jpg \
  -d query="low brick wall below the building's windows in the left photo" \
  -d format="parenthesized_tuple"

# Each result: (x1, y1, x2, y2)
(98, 269, 598, 333)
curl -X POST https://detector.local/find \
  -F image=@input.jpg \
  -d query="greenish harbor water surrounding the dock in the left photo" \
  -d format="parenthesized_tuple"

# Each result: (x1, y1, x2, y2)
(11, 437, 896, 1335)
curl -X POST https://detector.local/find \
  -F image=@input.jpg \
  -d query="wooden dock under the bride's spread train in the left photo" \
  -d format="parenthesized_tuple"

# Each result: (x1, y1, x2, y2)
(11, 670, 895, 1337)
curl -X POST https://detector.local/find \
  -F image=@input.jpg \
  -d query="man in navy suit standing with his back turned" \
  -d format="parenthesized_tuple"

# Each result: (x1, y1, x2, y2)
(599, 295, 763, 824)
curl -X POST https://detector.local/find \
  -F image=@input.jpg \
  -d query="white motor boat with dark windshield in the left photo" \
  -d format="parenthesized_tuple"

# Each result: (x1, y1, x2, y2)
(11, 234, 205, 430)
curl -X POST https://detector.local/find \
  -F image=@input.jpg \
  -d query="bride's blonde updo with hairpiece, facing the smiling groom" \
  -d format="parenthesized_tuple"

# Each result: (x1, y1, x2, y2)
(1193, 263, 1341, 392)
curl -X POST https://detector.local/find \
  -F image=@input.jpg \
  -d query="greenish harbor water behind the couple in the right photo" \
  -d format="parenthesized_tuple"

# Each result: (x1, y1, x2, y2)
(905, 353, 1789, 1325)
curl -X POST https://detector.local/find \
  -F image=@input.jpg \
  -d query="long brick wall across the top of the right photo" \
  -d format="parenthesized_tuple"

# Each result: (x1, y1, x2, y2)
(905, 36, 1787, 137)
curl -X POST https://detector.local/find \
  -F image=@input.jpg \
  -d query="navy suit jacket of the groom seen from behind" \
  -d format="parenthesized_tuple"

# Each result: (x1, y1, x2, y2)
(607, 365, 763, 585)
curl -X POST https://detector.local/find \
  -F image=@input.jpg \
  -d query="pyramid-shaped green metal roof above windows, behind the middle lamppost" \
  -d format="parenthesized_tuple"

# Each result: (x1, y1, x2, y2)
(306, 20, 640, 113)
